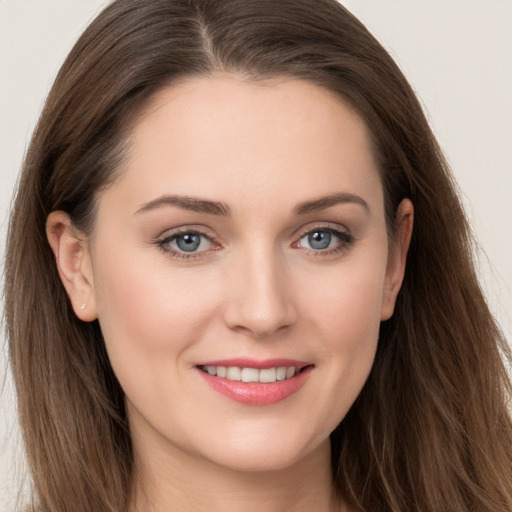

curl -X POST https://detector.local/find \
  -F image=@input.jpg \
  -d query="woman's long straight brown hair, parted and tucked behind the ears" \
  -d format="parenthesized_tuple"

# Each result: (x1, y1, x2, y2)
(5, 0, 512, 512)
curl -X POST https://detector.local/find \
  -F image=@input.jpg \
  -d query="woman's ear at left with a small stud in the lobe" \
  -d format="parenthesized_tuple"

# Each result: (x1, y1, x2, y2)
(46, 211, 98, 322)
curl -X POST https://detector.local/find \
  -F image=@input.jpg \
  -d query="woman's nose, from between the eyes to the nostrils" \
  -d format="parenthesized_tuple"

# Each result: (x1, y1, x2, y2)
(224, 248, 298, 338)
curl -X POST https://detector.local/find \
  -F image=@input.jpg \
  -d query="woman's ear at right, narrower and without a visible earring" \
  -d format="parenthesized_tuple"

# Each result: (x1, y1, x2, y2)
(380, 199, 414, 320)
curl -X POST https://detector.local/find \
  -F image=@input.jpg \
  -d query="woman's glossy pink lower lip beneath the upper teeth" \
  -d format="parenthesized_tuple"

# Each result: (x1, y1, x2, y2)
(196, 366, 313, 405)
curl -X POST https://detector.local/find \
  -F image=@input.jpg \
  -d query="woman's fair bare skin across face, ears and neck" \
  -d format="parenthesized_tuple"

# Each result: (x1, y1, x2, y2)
(47, 75, 413, 512)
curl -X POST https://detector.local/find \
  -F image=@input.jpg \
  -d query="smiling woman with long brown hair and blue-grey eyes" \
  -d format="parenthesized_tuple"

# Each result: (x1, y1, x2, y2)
(6, 0, 512, 512)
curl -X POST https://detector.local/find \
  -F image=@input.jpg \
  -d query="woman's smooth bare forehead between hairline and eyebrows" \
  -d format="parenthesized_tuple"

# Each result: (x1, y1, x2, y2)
(100, 75, 382, 218)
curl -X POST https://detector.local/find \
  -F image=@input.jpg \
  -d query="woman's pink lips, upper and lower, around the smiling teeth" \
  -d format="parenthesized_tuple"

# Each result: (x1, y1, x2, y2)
(195, 359, 313, 405)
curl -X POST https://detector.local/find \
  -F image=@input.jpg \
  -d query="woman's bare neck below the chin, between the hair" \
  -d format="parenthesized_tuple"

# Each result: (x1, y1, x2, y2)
(132, 434, 345, 512)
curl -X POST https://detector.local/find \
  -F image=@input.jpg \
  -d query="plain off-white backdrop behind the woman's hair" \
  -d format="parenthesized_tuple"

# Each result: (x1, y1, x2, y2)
(0, 0, 512, 511)
